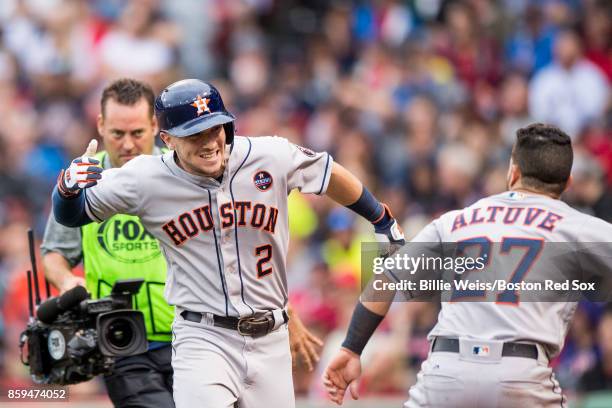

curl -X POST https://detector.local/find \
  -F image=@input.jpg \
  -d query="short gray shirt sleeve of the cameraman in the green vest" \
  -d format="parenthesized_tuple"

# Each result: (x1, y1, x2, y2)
(40, 211, 83, 267)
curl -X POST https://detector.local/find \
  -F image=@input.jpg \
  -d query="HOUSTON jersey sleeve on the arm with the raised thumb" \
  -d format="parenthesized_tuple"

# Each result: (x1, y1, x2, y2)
(84, 156, 143, 222)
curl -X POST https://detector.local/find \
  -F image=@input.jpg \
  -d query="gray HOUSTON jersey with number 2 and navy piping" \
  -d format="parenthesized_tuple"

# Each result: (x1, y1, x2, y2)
(85, 136, 332, 316)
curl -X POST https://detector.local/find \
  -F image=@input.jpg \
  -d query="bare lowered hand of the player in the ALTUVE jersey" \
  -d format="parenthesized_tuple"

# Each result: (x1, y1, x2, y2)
(323, 348, 361, 405)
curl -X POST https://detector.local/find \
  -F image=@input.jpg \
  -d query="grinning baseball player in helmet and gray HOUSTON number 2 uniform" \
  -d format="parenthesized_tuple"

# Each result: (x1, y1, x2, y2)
(53, 79, 404, 408)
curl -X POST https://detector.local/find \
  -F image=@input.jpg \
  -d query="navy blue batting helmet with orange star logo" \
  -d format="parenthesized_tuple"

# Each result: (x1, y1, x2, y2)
(155, 79, 236, 144)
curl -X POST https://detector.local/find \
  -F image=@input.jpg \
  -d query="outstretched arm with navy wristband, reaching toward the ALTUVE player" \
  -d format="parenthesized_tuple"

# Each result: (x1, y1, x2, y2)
(326, 162, 406, 256)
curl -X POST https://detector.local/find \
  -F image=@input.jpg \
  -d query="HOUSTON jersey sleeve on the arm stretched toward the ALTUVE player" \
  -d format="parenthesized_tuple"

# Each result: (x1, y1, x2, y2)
(286, 141, 333, 195)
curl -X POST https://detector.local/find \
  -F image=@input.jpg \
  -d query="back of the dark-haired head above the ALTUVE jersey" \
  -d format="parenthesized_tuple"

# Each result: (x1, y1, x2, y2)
(512, 123, 574, 195)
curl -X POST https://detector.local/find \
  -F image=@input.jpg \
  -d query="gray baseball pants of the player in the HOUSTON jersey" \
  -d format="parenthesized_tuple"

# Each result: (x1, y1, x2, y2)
(172, 307, 295, 408)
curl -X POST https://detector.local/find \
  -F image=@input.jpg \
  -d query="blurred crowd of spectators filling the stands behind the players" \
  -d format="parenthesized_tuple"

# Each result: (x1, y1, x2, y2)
(0, 0, 612, 404)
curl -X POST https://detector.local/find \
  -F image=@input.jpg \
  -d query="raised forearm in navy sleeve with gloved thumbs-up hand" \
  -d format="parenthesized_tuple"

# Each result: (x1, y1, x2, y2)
(52, 140, 102, 227)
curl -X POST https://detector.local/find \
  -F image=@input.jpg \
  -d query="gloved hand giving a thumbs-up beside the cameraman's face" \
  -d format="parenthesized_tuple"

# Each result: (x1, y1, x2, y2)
(57, 140, 102, 197)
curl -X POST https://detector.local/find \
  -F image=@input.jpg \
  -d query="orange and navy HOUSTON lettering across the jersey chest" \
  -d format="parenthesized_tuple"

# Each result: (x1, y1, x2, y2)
(162, 201, 278, 245)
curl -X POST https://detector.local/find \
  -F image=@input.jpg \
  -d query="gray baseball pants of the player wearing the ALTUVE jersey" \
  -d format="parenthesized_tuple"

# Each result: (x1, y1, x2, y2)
(404, 340, 566, 408)
